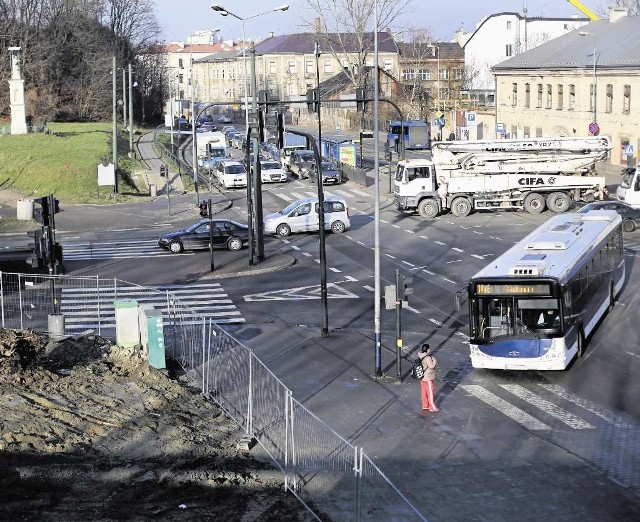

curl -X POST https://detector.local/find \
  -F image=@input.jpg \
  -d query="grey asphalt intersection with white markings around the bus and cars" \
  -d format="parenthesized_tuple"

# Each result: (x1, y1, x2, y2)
(52, 157, 640, 521)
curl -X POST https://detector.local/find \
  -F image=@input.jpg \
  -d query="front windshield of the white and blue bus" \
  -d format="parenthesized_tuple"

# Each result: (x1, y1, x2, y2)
(474, 297, 562, 342)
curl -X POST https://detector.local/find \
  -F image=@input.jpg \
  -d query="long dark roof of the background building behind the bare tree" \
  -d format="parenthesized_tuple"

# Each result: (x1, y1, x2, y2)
(256, 31, 398, 54)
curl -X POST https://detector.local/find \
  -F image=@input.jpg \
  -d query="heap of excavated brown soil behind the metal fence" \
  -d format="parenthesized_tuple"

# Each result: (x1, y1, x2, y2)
(0, 329, 324, 522)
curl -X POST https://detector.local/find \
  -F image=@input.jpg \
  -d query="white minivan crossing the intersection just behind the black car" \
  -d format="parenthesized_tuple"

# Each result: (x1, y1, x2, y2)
(264, 196, 351, 237)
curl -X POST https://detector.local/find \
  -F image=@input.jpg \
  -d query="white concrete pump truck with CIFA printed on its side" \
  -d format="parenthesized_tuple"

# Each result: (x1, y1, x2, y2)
(394, 137, 611, 219)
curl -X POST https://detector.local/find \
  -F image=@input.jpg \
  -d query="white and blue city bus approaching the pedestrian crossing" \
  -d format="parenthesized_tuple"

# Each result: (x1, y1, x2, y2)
(468, 210, 625, 370)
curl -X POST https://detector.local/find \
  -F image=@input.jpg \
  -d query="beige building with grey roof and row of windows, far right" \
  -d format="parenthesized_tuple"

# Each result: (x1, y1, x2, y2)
(487, 9, 640, 164)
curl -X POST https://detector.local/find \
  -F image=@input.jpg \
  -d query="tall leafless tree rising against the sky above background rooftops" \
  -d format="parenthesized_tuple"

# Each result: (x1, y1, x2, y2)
(306, 0, 412, 86)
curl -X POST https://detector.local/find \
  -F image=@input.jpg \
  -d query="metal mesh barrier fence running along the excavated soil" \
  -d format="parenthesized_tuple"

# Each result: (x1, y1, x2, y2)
(0, 272, 426, 522)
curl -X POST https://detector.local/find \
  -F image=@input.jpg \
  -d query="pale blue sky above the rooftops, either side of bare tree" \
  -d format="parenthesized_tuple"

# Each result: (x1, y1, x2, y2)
(155, 0, 584, 42)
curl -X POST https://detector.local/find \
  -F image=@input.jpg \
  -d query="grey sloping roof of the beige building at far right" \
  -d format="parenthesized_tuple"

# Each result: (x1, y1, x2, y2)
(492, 16, 640, 72)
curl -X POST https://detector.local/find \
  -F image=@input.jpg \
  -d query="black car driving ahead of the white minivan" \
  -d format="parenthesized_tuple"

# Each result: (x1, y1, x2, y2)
(158, 219, 249, 254)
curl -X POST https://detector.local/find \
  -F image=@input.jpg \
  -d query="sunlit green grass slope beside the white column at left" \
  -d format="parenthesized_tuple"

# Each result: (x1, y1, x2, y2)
(0, 123, 148, 203)
